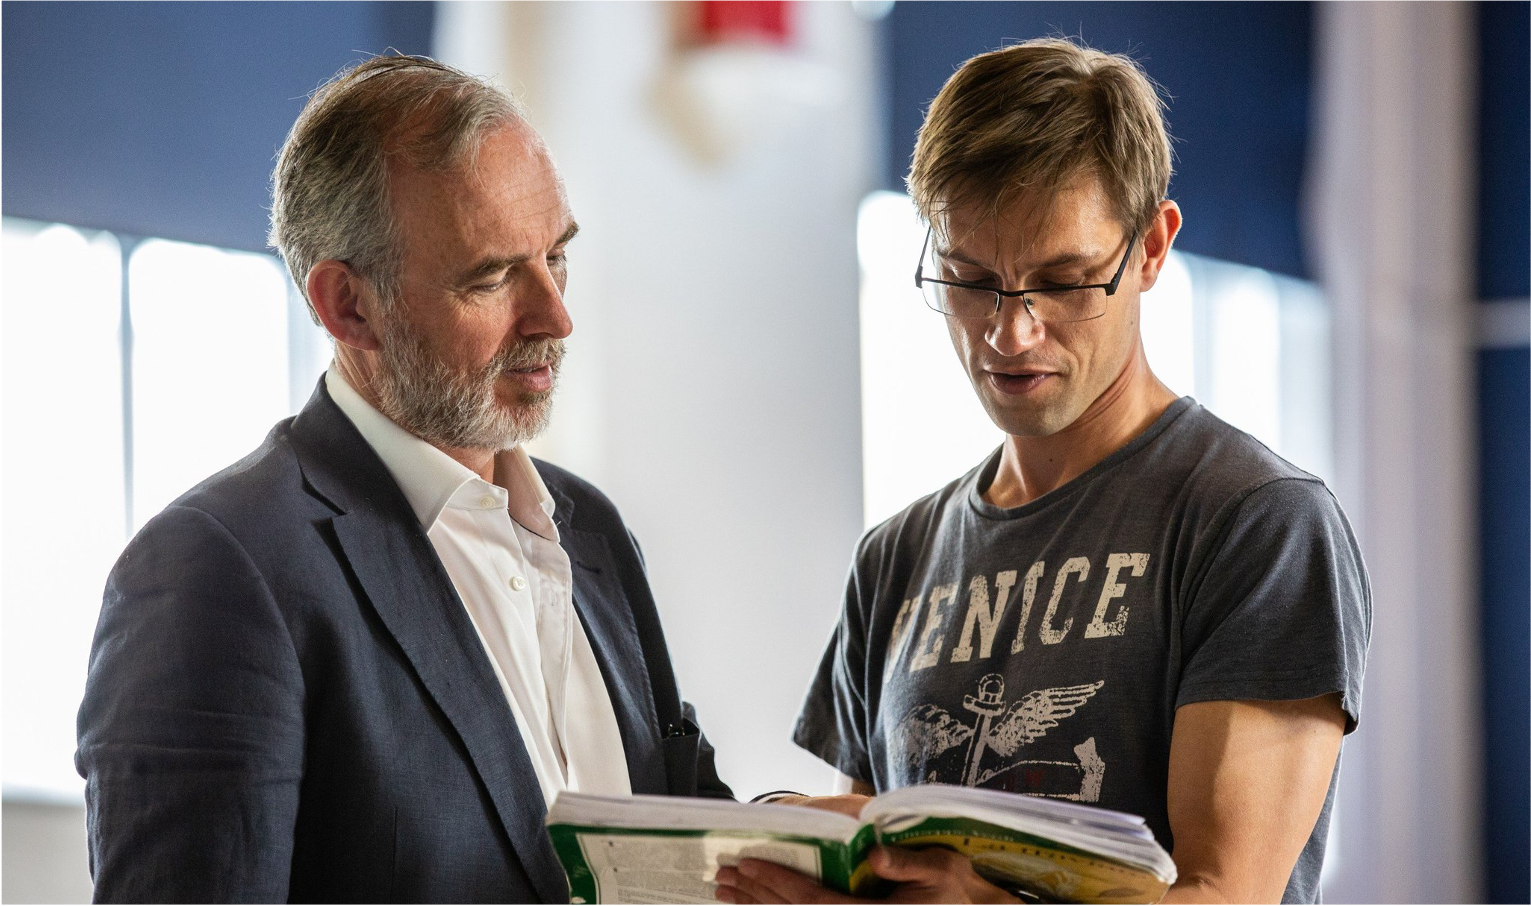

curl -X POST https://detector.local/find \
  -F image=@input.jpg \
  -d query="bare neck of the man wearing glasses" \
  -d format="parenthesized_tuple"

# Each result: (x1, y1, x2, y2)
(983, 343, 1176, 507)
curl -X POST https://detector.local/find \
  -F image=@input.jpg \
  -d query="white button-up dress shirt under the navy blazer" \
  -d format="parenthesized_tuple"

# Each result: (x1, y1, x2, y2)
(325, 366, 632, 803)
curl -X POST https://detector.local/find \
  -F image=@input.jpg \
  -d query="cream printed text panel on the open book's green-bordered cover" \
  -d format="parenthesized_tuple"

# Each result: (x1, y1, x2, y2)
(574, 833, 822, 903)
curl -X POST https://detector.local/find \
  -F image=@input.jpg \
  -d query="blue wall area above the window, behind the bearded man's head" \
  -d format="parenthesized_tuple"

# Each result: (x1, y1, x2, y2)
(0, 0, 435, 249)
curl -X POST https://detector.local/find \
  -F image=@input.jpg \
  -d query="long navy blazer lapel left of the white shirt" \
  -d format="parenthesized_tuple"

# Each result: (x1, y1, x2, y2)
(294, 380, 568, 901)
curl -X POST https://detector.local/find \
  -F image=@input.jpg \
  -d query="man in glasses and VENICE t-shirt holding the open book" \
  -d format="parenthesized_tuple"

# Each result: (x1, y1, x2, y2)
(720, 40, 1372, 903)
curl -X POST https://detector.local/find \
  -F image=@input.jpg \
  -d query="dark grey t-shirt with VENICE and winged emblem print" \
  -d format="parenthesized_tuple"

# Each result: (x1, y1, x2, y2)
(793, 398, 1372, 903)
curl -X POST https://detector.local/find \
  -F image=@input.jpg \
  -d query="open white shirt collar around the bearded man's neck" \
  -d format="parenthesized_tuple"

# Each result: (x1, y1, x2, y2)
(325, 364, 559, 542)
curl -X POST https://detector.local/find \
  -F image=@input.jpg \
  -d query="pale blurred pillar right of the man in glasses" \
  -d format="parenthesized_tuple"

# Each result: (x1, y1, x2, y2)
(1309, 0, 1482, 903)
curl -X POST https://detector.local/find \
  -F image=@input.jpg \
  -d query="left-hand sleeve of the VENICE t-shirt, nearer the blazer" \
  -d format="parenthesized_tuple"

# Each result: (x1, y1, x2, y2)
(792, 545, 873, 784)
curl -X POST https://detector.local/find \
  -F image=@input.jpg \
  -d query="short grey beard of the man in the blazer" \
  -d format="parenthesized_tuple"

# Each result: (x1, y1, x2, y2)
(375, 314, 563, 453)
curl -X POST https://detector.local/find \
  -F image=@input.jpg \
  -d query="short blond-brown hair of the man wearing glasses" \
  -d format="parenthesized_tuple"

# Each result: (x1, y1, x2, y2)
(908, 38, 1171, 234)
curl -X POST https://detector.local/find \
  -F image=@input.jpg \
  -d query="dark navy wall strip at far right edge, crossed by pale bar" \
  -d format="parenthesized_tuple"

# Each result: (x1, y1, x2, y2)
(1477, 0, 1531, 903)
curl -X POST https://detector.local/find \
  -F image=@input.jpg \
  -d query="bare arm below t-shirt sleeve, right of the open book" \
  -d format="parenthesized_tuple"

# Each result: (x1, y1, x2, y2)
(1165, 693, 1346, 903)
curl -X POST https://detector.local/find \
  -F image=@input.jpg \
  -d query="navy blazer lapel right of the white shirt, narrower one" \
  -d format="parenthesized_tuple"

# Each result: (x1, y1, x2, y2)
(553, 491, 668, 794)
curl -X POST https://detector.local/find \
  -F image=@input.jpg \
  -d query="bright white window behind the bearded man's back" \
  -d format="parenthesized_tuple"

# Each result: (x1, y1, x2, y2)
(0, 217, 329, 800)
